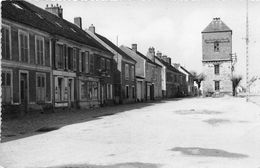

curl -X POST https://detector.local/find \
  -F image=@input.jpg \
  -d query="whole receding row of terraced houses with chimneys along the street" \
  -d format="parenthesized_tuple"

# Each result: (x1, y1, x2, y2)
(1, 1, 194, 117)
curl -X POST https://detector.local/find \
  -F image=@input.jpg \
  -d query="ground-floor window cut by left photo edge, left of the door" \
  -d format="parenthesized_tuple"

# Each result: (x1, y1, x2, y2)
(2, 70, 12, 103)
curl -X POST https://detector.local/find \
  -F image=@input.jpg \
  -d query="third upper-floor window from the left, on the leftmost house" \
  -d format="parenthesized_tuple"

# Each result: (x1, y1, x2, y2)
(35, 36, 45, 65)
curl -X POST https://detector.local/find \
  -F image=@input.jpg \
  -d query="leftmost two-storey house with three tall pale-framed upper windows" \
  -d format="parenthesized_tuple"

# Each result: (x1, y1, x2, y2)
(1, 1, 53, 115)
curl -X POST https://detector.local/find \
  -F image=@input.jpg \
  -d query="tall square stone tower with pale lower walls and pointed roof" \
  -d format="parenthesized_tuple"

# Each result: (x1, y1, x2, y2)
(202, 18, 232, 95)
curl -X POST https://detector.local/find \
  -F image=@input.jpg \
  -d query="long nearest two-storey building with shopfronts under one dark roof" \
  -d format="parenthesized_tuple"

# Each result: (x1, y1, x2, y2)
(1, 1, 114, 115)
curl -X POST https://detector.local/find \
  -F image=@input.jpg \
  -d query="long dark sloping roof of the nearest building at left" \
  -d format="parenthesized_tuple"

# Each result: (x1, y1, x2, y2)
(2, 1, 112, 54)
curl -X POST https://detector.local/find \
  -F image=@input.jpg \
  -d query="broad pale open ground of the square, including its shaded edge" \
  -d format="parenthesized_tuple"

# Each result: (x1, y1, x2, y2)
(0, 97, 260, 168)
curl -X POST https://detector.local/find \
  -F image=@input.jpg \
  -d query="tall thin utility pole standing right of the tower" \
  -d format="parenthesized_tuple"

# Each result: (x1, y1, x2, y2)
(246, 0, 249, 102)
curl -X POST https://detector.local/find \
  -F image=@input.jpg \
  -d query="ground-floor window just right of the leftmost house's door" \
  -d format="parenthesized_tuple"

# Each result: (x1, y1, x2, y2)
(36, 74, 46, 102)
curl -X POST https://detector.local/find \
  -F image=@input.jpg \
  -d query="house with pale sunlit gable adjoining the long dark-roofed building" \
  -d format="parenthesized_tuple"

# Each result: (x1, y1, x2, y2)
(86, 25, 136, 104)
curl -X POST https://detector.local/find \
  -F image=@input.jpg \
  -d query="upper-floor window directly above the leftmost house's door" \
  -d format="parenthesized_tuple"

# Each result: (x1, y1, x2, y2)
(19, 31, 29, 62)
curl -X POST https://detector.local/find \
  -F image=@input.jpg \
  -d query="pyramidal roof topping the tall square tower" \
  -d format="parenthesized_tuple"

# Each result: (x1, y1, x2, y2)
(202, 18, 232, 33)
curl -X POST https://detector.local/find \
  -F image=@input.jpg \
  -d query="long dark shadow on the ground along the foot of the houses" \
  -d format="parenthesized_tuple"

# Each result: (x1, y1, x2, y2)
(1, 99, 181, 142)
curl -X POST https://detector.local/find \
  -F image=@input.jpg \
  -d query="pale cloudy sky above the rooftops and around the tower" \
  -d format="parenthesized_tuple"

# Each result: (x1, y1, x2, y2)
(30, 0, 260, 82)
